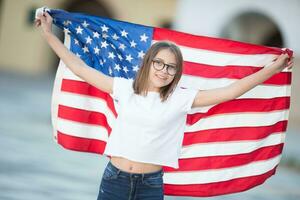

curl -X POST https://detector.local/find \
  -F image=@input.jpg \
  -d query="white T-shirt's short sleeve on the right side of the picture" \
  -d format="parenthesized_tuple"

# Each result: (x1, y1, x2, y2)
(175, 87, 198, 112)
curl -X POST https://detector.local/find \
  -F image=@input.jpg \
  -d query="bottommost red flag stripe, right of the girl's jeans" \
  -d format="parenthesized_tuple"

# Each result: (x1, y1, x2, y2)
(164, 166, 277, 197)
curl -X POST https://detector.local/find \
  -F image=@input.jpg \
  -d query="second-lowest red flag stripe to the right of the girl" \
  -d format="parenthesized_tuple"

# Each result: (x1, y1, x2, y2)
(163, 143, 283, 172)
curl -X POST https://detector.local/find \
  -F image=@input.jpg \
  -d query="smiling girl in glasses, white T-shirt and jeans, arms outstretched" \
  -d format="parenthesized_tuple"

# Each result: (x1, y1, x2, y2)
(35, 12, 293, 200)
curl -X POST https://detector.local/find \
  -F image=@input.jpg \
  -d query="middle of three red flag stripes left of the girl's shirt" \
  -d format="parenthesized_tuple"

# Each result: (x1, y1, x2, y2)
(58, 105, 111, 134)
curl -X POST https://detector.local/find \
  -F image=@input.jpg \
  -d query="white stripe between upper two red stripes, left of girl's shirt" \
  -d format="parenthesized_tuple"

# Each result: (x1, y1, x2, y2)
(59, 92, 116, 128)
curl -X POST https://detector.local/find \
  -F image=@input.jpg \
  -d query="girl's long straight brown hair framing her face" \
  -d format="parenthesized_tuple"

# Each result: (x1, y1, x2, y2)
(133, 41, 183, 102)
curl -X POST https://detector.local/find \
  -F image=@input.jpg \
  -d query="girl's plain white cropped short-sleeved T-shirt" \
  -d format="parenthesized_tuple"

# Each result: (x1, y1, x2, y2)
(104, 77, 197, 168)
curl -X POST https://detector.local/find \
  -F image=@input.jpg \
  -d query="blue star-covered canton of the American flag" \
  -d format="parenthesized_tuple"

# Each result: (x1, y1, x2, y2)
(50, 10, 153, 79)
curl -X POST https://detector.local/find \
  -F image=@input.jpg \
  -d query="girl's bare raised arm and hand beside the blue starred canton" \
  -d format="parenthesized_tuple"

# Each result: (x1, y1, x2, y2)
(35, 12, 113, 93)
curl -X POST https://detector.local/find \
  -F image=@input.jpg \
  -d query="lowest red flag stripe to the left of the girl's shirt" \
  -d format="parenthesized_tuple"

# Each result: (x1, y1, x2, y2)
(57, 131, 106, 154)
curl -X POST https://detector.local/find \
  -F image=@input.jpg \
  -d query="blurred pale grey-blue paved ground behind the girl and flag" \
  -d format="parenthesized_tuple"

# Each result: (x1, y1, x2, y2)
(0, 73, 300, 200)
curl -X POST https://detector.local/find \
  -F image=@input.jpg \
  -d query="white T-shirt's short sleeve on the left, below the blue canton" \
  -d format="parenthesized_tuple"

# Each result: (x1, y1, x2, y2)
(112, 77, 133, 103)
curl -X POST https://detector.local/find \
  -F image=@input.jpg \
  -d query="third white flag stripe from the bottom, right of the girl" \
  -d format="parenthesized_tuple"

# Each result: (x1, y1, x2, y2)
(185, 110, 288, 132)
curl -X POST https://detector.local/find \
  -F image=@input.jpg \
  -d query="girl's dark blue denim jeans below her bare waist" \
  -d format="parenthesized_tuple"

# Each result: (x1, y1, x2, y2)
(97, 161, 164, 200)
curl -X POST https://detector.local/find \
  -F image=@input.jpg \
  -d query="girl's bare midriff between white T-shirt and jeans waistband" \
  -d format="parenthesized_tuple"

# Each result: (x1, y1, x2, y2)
(110, 156, 162, 173)
